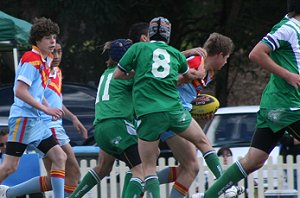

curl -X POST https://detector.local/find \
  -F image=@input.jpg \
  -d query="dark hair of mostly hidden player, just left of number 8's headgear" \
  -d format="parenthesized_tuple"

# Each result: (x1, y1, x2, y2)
(128, 22, 149, 43)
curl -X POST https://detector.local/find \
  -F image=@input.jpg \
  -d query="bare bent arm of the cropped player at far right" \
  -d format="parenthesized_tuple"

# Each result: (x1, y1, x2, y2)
(249, 42, 300, 88)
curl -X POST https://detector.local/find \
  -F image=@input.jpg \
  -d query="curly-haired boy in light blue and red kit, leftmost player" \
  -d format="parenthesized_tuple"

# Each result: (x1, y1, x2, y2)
(0, 18, 67, 198)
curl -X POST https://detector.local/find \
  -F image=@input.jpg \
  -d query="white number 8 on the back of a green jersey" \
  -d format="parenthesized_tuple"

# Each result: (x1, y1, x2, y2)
(152, 48, 170, 78)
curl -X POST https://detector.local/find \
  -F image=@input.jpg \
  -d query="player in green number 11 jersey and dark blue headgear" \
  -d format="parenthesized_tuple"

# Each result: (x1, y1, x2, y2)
(70, 39, 143, 198)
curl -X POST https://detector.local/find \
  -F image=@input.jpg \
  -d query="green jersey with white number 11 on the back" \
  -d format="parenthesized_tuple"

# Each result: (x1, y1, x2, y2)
(94, 66, 134, 125)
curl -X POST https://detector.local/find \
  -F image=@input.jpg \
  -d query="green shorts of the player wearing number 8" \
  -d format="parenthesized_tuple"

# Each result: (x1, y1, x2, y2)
(137, 109, 192, 141)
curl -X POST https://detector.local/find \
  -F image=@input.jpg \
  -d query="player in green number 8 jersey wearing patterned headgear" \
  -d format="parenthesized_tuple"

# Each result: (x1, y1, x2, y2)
(114, 17, 222, 197)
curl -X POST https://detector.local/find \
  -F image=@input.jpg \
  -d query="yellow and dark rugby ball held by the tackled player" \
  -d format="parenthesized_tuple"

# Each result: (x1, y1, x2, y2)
(191, 94, 220, 117)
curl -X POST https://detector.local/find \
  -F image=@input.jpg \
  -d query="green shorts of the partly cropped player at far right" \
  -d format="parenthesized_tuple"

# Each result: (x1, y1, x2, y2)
(256, 108, 300, 133)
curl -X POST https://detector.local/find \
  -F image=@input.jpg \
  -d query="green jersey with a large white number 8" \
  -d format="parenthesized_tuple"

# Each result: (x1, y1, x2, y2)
(118, 41, 188, 117)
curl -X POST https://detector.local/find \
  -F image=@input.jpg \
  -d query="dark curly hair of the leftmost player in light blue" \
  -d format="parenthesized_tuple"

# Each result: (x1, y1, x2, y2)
(29, 17, 59, 45)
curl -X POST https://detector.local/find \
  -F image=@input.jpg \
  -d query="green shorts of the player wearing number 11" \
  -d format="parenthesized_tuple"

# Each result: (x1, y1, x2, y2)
(94, 118, 137, 158)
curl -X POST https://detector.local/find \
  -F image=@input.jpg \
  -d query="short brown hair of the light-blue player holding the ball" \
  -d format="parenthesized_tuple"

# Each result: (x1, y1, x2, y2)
(203, 32, 234, 56)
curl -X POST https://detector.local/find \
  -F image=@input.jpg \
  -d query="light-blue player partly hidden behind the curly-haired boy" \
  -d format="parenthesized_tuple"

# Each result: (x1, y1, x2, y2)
(0, 43, 87, 197)
